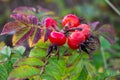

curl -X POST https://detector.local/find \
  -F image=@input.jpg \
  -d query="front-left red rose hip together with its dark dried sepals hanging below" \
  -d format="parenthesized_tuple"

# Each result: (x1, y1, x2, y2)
(47, 31, 66, 58)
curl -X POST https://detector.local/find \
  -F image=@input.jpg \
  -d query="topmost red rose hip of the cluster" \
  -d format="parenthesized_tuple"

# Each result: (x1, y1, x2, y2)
(62, 14, 80, 28)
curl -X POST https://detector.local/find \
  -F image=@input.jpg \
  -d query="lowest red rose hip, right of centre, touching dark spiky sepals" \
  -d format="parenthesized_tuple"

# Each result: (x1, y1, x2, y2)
(68, 31, 85, 49)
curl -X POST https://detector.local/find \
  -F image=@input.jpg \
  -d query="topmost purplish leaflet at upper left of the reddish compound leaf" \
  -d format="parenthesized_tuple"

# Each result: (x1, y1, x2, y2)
(13, 6, 36, 14)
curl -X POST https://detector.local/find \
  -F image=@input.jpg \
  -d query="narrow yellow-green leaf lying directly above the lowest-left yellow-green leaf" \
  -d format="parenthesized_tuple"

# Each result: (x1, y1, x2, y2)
(14, 57, 44, 67)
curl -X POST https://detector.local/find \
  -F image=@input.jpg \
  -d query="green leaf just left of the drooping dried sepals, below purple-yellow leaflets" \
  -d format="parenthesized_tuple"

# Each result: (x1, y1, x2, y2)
(29, 47, 47, 58)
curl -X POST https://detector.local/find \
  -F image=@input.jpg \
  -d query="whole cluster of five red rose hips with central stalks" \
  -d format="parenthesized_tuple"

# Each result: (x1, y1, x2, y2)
(44, 14, 91, 49)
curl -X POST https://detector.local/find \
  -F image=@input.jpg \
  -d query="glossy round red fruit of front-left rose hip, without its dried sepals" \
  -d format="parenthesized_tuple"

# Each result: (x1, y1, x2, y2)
(49, 31, 66, 46)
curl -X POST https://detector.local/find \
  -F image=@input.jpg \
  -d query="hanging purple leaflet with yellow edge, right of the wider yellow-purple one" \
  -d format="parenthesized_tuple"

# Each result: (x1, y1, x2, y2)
(28, 28, 42, 47)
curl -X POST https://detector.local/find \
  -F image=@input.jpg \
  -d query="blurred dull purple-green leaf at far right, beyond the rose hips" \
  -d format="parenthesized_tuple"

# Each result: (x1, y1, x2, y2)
(98, 24, 115, 44)
